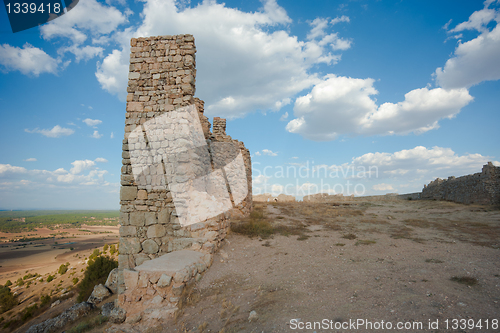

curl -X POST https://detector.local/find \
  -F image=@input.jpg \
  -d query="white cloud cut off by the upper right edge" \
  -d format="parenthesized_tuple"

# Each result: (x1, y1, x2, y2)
(435, 2, 500, 88)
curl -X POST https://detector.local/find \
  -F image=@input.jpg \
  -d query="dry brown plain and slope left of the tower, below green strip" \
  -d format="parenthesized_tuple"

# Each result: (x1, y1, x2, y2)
(0, 226, 119, 332)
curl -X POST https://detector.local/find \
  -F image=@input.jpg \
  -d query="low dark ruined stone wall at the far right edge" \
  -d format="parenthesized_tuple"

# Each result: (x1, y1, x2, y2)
(421, 162, 500, 205)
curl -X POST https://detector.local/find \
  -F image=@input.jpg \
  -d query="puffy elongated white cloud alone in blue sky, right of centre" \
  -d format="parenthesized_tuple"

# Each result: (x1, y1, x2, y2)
(286, 74, 472, 141)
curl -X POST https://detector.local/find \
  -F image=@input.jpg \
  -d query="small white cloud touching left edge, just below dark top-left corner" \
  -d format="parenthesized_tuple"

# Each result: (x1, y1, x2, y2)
(0, 43, 59, 76)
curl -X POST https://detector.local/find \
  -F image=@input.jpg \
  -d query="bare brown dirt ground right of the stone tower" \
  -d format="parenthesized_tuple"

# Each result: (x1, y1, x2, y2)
(113, 200, 500, 333)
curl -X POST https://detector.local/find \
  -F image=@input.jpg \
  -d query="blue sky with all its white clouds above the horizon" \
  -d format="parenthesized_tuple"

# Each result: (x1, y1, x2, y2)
(0, 0, 500, 209)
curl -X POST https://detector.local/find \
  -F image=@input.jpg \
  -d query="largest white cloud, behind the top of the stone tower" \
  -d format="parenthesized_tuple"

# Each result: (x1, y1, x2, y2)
(96, 0, 345, 118)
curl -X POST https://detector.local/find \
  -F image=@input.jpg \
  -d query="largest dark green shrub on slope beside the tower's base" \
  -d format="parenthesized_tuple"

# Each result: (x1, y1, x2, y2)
(77, 254, 118, 302)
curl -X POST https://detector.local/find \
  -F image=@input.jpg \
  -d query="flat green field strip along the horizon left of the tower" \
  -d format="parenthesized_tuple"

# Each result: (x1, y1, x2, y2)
(0, 210, 120, 232)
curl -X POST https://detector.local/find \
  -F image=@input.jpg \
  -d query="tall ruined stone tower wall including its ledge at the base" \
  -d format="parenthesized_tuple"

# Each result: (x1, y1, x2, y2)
(119, 35, 252, 322)
